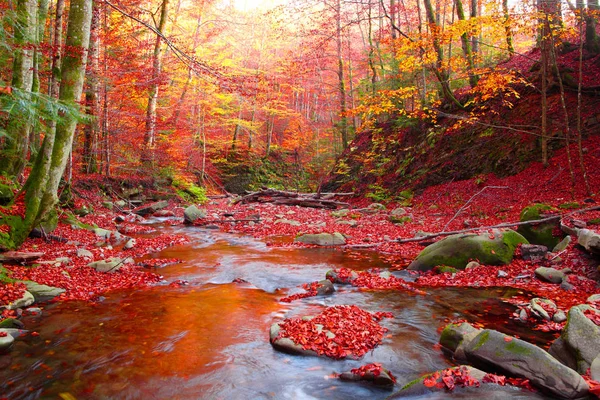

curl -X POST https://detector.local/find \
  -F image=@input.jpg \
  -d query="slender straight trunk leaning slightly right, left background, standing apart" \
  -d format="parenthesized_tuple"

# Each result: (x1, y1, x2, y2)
(142, 0, 169, 161)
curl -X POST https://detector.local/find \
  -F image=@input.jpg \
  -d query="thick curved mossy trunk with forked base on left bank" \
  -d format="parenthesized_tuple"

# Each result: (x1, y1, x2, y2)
(4, 0, 92, 248)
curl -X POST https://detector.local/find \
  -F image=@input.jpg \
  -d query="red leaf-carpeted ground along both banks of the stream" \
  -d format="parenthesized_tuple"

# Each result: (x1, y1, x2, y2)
(0, 130, 600, 331)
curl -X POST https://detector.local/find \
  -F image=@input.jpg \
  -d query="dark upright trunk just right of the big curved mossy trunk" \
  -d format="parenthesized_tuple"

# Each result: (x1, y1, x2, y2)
(82, 1, 100, 174)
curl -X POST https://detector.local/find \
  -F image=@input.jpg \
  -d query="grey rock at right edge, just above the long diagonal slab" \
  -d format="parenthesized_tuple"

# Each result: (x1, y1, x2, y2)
(560, 304, 600, 374)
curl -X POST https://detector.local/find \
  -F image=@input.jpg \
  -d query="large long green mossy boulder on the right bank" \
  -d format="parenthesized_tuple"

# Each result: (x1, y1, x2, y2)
(408, 230, 527, 271)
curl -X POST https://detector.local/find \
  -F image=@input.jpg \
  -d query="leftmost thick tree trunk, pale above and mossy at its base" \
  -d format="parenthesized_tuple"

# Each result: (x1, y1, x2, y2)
(0, 0, 38, 179)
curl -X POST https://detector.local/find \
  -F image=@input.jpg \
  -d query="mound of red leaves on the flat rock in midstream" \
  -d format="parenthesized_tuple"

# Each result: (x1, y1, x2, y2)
(279, 305, 394, 359)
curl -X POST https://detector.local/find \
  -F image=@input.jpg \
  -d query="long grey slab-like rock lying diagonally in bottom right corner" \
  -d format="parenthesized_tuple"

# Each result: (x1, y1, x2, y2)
(465, 329, 589, 399)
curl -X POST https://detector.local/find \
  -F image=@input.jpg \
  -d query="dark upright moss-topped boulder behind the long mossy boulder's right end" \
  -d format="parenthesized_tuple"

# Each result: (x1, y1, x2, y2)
(517, 203, 564, 249)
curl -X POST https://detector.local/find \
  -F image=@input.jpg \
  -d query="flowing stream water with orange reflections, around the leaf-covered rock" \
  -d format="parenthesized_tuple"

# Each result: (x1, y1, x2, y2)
(0, 223, 547, 400)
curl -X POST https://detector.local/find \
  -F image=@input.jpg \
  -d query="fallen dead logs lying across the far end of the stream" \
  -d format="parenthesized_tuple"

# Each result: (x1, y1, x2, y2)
(235, 189, 353, 210)
